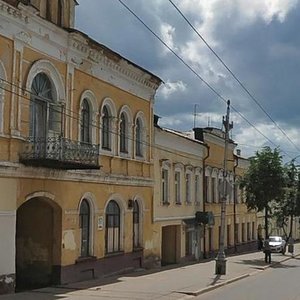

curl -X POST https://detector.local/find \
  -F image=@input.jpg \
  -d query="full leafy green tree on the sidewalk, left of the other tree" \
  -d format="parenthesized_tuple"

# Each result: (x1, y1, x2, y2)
(240, 147, 285, 239)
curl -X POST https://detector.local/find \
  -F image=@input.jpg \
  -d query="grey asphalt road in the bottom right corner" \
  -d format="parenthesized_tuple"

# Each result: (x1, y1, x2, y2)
(198, 258, 300, 300)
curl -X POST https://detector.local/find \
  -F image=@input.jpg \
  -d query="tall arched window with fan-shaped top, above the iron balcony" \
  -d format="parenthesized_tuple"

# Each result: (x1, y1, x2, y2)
(29, 73, 61, 138)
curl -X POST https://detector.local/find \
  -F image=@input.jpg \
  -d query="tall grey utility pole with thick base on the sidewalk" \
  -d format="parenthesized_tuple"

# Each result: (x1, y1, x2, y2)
(215, 100, 233, 275)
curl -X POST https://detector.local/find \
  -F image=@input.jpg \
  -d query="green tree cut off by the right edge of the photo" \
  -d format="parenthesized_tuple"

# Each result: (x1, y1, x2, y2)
(274, 159, 300, 240)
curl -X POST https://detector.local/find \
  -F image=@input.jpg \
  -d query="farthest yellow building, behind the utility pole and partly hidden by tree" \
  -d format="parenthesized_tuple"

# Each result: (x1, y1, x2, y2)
(194, 127, 257, 257)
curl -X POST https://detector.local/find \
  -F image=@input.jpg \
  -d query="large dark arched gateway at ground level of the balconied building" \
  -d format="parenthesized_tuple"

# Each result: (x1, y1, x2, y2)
(16, 197, 62, 290)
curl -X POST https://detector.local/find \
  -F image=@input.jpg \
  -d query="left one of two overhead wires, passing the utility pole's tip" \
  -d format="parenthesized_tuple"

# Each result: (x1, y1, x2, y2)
(118, 0, 296, 162)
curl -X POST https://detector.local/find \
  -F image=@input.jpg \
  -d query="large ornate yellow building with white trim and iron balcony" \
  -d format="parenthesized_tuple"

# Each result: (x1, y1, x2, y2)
(0, 0, 161, 293)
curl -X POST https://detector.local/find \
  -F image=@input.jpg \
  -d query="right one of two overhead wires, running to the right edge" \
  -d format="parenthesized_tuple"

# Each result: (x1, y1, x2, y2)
(169, 0, 300, 151)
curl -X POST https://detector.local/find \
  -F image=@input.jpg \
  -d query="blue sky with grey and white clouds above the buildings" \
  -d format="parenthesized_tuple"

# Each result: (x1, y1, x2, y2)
(75, 0, 300, 162)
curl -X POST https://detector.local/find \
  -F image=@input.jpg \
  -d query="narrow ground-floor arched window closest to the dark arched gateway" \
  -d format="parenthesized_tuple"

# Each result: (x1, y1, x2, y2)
(79, 199, 90, 257)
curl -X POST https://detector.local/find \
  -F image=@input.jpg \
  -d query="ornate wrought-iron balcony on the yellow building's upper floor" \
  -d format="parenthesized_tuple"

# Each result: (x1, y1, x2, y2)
(20, 136, 100, 170)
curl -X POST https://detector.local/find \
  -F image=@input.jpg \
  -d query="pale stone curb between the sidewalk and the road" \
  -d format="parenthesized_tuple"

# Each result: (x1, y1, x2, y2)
(182, 254, 300, 296)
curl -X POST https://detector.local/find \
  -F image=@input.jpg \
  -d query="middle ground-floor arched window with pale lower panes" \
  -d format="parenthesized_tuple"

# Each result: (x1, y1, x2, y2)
(105, 200, 121, 253)
